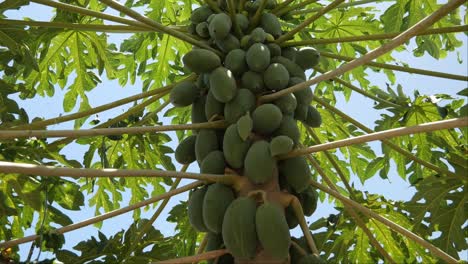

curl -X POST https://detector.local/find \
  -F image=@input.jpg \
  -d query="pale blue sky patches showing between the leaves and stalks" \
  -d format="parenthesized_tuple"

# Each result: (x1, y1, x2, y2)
(6, 1, 468, 258)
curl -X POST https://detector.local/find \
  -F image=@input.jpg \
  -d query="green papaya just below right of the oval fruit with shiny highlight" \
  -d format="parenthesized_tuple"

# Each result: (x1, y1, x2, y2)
(224, 89, 255, 124)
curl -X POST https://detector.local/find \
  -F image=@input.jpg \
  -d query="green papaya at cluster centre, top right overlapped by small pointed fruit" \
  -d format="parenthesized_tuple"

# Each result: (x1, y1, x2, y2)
(223, 124, 252, 169)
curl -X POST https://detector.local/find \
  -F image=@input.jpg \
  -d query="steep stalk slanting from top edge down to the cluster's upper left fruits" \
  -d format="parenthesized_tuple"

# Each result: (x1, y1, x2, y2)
(101, 0, 223, 57)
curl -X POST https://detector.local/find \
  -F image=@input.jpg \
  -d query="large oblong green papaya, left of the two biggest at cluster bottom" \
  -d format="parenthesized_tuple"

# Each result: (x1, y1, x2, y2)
(222, 197, 257, 260)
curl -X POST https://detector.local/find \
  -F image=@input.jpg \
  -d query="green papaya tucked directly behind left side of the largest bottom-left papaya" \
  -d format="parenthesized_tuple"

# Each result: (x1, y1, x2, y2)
(202, 183, 235, 233)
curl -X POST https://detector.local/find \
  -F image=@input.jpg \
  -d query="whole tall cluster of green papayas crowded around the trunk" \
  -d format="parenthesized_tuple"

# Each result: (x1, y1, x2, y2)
(170, 0, 322, 263)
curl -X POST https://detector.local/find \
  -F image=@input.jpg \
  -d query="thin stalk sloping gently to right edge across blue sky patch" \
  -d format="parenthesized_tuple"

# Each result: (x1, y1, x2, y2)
(320, 52, 468, 81)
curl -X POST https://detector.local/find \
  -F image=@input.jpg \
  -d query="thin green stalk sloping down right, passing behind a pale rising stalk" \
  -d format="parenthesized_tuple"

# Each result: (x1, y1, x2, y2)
(308, 96, 466, 177)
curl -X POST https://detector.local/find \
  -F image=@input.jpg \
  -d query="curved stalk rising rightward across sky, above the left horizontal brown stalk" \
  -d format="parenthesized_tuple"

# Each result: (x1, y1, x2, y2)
(9, 74, 197, 130)
